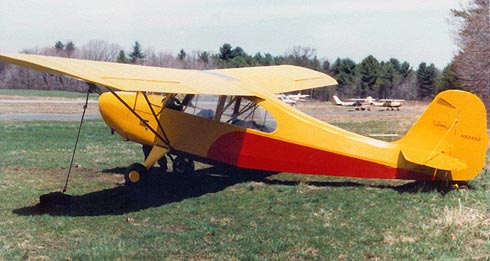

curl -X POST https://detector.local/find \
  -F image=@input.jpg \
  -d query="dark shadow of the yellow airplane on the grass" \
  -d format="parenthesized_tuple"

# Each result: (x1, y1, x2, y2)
(13, 167, 456, 217)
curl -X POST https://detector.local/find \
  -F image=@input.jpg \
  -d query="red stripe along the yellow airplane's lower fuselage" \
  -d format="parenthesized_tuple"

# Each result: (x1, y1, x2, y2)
(208, 132, 430, 180)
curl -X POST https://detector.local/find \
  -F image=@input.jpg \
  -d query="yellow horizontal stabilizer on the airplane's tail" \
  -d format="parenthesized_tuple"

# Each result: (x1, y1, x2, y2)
(402, 149, 468, 170)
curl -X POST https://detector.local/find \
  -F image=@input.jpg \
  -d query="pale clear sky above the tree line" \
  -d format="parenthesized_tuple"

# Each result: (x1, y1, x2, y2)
(0, 0, 467, 69)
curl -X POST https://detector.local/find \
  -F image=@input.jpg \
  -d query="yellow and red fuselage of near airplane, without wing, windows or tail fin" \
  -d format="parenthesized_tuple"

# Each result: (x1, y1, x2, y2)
(99, 92, 486, 180)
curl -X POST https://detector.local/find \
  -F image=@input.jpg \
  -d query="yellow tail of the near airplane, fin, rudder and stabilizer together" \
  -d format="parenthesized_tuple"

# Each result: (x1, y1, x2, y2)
(399, 90, 488, 181)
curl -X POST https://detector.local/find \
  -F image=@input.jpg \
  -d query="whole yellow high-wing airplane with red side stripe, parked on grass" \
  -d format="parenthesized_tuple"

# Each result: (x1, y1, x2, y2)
(0, 54, 488, 184)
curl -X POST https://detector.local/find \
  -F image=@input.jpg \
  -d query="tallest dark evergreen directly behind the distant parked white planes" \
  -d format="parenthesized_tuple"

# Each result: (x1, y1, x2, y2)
(359, 55, 380, 98)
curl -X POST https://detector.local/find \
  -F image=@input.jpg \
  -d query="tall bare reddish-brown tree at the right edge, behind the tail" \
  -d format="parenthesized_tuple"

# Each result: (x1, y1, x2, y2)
(451, 0, 490, 105)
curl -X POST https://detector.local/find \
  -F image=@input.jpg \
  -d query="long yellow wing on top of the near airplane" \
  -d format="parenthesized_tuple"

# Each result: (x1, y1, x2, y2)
(0, 54, 337, 96)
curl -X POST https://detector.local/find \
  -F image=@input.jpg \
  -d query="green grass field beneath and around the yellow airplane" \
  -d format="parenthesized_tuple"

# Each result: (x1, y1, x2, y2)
(0, 121, 490, 260)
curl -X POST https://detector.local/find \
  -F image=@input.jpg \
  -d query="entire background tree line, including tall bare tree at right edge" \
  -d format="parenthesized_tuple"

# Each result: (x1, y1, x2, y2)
(0, 0, 490, 104)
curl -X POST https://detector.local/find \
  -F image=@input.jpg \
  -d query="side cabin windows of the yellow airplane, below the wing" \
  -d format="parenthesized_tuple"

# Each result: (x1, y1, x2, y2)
(184, 95, 277, 133)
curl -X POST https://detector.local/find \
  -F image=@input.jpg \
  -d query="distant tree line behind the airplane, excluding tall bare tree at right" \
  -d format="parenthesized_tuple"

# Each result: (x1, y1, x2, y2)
(0, 40, 442, 100)
